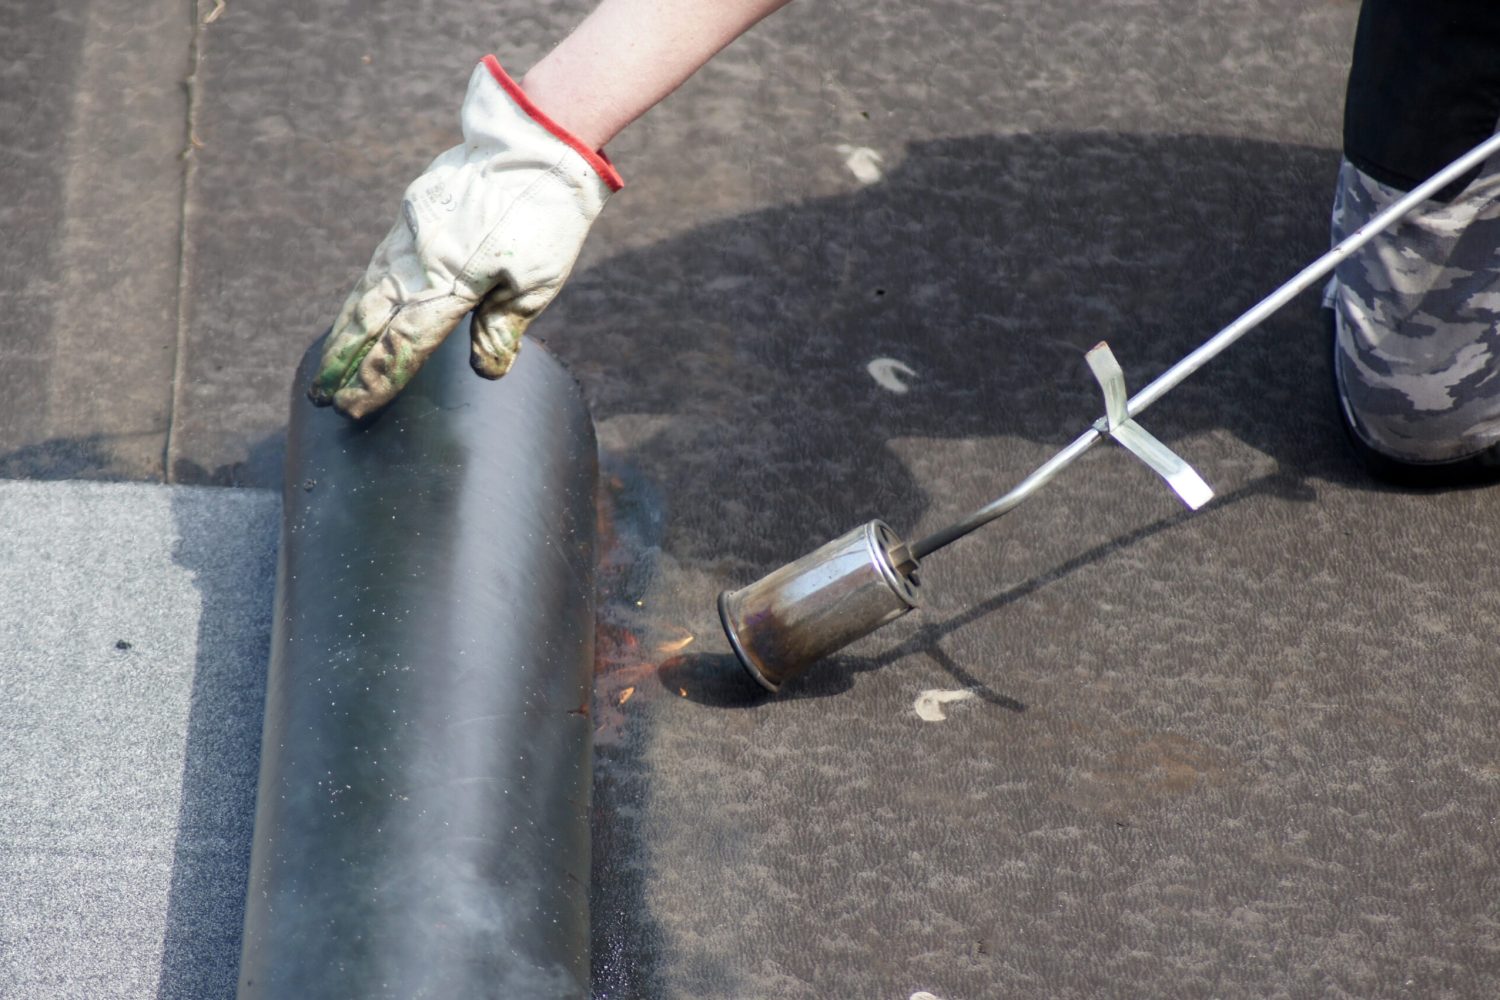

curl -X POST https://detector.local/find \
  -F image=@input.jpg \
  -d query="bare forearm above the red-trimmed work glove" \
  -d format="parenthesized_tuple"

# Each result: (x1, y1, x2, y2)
(521, 0, 789, 148)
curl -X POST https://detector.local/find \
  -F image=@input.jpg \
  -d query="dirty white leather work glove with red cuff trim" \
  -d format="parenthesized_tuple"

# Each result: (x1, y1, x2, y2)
(308, 55, 624, 418)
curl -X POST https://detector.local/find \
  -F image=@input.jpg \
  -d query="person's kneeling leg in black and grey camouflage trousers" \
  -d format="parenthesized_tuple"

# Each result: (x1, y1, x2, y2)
(1326, 0, 1500, 486)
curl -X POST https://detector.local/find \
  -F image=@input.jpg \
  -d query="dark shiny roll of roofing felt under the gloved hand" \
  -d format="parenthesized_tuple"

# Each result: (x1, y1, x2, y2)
(239, 328, 597, 1000)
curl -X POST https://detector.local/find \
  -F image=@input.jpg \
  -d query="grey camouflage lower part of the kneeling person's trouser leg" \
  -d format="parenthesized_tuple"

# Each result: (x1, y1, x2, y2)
(1323, 150, 1500, 463)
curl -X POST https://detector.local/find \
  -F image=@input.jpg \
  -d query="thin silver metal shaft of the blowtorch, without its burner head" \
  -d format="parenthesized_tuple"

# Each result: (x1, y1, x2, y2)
(909, 133, 1500, 559)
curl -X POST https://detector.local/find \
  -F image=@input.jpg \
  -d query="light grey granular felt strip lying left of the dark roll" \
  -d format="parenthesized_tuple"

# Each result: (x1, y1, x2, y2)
(0, 483, 281, 1000)
